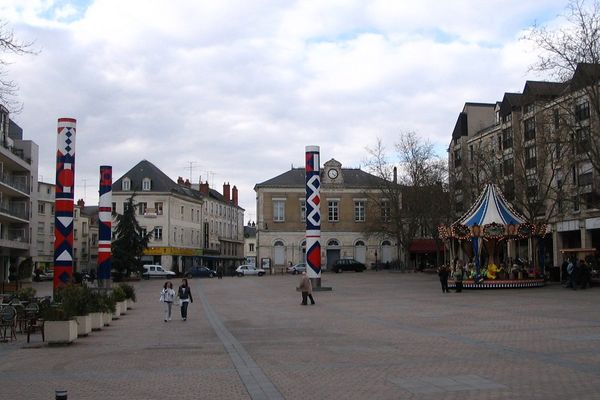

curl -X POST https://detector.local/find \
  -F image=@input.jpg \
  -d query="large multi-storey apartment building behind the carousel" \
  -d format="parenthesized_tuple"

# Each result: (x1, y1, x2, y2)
(448, 64, 600, 266)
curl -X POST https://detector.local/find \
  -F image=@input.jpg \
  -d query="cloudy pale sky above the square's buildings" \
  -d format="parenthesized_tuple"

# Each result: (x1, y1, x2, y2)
(0, 0, 566, 220)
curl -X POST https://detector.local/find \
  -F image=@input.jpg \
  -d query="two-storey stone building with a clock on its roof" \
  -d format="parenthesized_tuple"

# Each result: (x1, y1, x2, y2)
(254, 159, 396, 269)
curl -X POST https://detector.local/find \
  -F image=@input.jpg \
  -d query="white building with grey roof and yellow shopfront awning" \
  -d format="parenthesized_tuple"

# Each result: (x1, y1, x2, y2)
(112, 160, 244, 272)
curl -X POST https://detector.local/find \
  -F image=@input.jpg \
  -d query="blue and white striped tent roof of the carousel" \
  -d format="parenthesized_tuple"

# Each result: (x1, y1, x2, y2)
(455, 183, 525, 226)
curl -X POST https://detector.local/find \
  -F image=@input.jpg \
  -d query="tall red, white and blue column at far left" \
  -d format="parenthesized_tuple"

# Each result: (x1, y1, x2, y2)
(53, 118, 77, 290)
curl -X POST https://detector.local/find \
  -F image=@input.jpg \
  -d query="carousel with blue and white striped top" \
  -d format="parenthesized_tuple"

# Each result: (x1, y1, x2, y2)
(438, 184, 547, 289)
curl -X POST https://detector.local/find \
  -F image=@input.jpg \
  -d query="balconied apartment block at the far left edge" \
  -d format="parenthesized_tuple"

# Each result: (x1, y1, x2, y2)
(0, 105, 38, 282)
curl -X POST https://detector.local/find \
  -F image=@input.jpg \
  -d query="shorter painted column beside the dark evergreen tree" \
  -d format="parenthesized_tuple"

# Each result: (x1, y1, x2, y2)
(98, 165, 112, 287)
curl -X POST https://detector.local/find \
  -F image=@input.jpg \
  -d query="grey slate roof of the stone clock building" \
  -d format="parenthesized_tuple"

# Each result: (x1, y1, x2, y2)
(254, 168, 383, 190)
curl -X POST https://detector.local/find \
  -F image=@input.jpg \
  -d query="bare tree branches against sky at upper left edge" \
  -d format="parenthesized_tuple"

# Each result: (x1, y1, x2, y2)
(0, 21, 35, 112)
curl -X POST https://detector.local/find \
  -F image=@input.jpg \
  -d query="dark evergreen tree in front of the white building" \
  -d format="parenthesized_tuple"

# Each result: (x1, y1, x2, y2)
(111, 194, 152, 276)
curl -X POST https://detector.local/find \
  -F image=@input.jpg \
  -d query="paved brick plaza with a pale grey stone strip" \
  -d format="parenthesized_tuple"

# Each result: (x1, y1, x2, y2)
(0, 271, 600, 400)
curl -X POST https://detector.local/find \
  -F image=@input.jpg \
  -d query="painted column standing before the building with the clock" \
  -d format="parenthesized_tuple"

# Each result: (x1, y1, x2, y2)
(305, 146, 321, 287)
